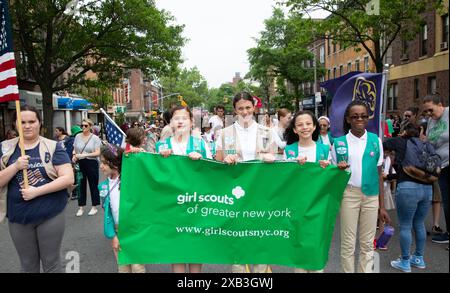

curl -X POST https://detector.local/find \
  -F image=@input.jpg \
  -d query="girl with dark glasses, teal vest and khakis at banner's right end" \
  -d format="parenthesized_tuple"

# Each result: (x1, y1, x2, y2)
(332, 100, 390, 273)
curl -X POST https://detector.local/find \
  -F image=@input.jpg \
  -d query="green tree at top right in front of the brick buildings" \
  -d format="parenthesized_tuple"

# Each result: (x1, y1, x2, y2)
(284, 0, 443, 72)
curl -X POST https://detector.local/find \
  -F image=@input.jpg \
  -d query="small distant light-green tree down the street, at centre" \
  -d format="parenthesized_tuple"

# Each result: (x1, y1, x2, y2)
(159, 67, 208, 109)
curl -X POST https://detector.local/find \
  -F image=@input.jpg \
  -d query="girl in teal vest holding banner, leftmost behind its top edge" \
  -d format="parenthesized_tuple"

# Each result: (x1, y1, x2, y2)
(156, 106, 212, 273)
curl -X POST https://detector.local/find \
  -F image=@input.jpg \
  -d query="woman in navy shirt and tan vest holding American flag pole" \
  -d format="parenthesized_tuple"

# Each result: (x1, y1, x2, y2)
(0, 106, 73, 273)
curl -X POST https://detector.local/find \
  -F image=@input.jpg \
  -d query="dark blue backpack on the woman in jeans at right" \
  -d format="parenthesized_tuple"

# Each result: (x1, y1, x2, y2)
(401, 137, 441, 184)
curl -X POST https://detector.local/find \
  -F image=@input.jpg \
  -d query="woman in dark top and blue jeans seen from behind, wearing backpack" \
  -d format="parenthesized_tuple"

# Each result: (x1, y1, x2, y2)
(383, 123, 433, 272)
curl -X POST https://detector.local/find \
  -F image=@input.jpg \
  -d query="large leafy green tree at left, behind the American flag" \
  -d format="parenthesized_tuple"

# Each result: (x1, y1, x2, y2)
(11, 0, 185, 136)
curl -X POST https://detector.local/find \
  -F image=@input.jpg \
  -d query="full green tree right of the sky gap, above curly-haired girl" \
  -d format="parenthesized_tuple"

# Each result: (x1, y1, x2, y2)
(247, 8, 324, 109)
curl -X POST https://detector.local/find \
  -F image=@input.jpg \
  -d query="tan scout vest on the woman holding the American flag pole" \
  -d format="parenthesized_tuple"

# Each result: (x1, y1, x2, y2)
(0, 136, 57, 223)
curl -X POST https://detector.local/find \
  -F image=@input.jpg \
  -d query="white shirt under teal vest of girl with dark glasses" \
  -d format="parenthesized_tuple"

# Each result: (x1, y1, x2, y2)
(331, 130, 384, 187)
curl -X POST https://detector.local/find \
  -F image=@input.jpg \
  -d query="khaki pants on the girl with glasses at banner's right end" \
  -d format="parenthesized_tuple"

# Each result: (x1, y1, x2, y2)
(340, 186, 379, 273)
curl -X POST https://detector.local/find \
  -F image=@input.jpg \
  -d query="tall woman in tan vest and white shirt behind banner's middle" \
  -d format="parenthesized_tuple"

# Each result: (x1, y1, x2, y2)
(216, 92, 277, 273)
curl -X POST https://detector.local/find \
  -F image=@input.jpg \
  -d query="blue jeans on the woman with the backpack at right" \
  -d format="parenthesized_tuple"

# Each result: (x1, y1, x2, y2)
(395, 181, 433, 259)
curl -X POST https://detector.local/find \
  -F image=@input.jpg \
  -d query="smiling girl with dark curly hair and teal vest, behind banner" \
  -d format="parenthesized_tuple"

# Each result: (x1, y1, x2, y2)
(284, 111, 330, 273)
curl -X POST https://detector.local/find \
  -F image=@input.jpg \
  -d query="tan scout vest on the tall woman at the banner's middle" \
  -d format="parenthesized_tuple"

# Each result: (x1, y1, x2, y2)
(217, 122, 277, 161)
